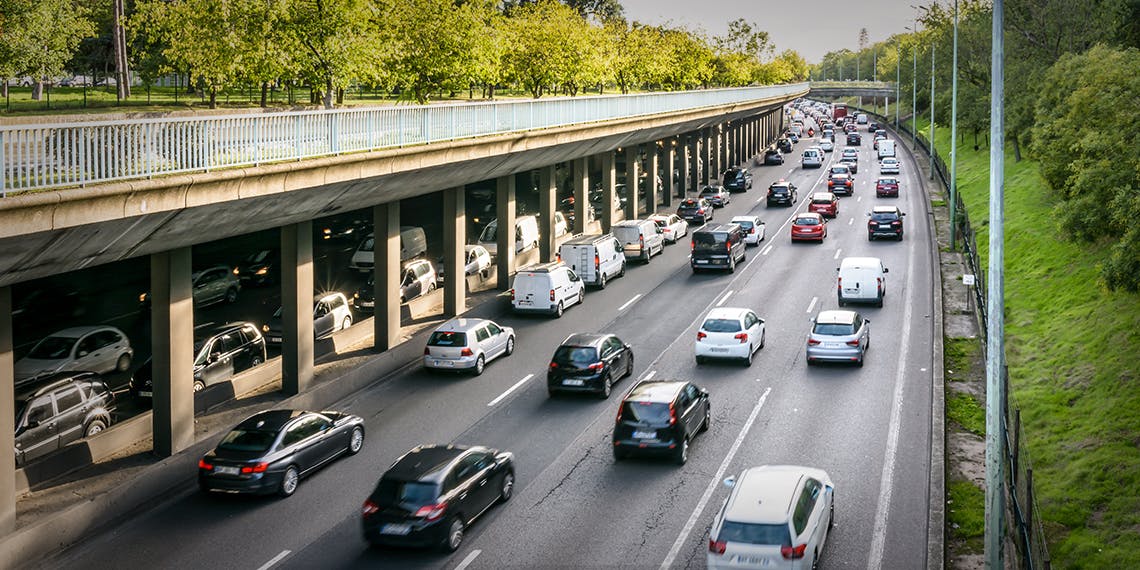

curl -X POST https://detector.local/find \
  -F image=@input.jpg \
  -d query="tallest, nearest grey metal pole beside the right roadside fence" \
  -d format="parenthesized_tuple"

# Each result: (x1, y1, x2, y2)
(985, 0, 1005, 570)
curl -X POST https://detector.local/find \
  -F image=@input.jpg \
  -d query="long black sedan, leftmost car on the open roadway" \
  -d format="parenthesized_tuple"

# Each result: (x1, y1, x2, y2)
(198, 409, 364, 497)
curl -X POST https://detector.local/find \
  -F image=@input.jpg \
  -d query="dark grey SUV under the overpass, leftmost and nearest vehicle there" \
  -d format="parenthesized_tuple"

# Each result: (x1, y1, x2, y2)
(16, 372, 115, 465)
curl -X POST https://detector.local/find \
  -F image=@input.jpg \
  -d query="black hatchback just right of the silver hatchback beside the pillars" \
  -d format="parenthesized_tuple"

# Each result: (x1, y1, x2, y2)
(546, 333, 634, 399)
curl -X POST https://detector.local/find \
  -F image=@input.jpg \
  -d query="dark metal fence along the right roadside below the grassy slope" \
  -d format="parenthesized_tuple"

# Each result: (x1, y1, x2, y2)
(848, 106, 1051, 570)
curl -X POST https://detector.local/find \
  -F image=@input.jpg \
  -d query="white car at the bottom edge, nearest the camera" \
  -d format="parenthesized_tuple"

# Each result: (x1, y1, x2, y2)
(706, 465, 836, 570)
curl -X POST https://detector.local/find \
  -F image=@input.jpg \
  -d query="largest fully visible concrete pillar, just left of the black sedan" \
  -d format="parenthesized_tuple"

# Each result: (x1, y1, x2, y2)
(150, 247, 194, 457)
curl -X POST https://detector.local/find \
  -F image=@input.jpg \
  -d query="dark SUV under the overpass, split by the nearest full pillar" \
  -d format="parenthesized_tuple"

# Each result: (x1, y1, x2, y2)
(131, 323, 266, 398)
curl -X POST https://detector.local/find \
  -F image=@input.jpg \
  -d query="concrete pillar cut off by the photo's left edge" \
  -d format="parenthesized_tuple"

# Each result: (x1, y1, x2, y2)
(0, 286, 16, 536)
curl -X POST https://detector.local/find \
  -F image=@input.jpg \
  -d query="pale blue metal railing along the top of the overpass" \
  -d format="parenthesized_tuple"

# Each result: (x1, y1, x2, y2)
(0, 83, 807, 196)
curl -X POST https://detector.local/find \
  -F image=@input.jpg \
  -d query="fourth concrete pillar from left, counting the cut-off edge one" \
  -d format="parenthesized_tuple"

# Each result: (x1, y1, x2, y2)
(372, 201, 401, 351)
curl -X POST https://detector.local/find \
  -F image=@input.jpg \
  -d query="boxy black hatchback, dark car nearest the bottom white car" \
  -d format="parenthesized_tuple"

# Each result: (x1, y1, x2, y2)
(613, 381, 711, 465)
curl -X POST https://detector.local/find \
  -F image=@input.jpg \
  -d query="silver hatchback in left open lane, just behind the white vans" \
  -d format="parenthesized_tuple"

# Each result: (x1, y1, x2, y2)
(424, 318, 514, 376)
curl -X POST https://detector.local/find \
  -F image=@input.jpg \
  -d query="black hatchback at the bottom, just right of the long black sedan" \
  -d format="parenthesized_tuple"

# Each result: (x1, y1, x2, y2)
(360, 446, 514, 552)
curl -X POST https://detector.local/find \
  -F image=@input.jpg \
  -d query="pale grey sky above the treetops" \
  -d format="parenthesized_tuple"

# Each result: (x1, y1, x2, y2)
(620, 0, 931, 64)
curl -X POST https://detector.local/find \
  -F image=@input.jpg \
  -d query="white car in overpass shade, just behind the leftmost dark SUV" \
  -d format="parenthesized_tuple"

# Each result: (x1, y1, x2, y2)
(14, 326, 135, 388)
